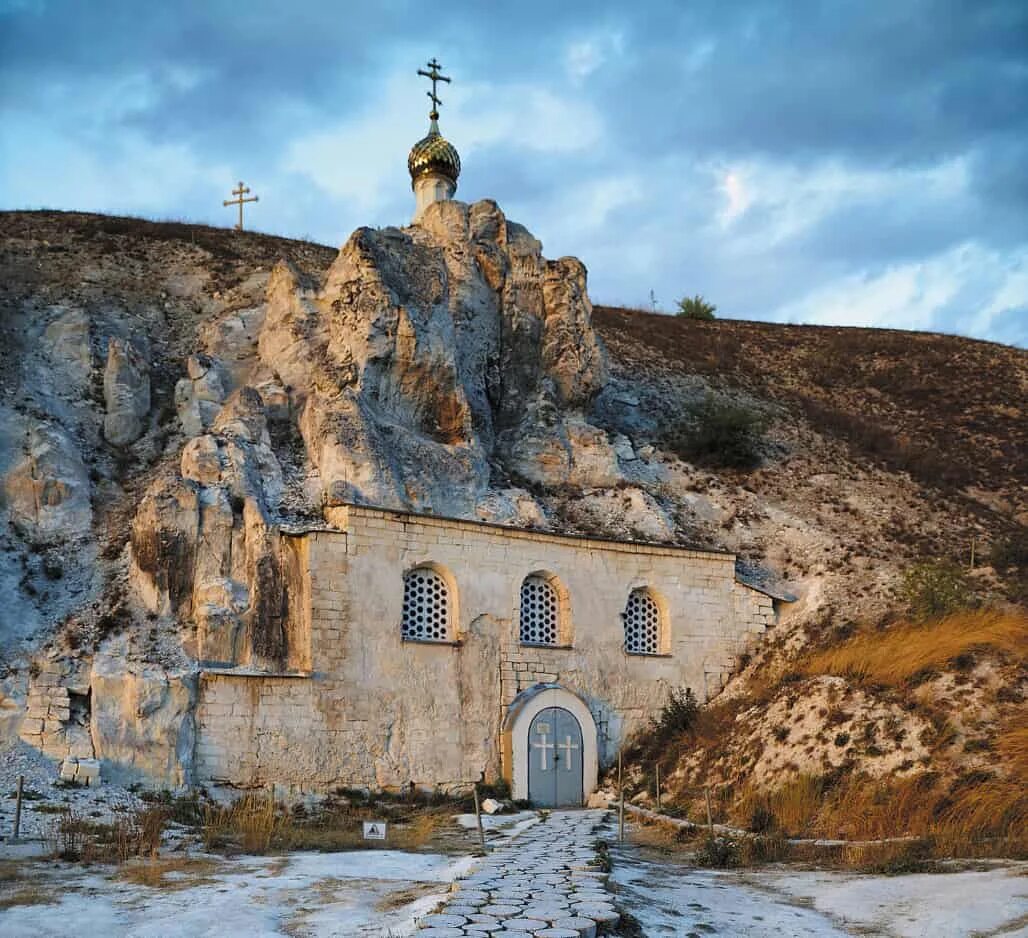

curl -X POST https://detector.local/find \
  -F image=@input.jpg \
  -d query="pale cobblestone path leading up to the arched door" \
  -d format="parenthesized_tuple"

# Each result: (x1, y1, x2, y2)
(416, 810, 620, 938)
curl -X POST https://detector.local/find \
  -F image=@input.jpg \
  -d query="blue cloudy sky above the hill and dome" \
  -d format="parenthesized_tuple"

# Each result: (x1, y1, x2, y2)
(0, 0, 1028, 346)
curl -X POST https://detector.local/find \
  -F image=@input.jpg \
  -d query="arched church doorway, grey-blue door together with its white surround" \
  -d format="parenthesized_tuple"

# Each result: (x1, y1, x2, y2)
(501, 684, 599, 806)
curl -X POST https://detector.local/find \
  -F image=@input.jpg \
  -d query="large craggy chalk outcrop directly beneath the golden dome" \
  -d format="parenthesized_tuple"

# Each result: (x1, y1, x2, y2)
(259, 202, 616, 516)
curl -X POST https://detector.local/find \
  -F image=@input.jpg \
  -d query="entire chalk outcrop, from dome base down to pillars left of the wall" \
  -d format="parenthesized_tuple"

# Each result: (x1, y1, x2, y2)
(124, 202, 621, 678)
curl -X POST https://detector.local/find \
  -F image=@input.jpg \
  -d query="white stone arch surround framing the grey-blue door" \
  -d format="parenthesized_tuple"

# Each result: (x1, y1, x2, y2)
(501, 684, 599, 804)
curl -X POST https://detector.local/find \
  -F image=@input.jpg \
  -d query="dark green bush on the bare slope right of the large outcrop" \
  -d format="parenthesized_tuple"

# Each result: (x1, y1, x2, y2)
(666, 395, 767, 469)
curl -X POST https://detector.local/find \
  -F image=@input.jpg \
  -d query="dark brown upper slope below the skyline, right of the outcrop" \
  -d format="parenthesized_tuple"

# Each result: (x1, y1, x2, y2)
(594, 305, 1028, 511)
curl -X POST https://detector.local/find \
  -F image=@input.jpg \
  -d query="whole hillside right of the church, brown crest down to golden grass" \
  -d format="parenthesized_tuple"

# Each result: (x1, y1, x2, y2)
(595, 306, 1028, 855)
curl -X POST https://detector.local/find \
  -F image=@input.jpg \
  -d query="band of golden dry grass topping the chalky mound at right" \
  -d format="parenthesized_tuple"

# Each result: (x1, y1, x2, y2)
(799, 610, 1028, 686)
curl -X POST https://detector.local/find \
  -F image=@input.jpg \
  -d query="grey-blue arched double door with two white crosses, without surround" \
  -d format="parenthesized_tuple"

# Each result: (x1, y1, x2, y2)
(528, 707, 583, 807)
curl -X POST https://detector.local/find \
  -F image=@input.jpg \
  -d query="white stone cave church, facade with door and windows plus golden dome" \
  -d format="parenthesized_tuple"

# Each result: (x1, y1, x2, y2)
(195, 67, 775, 805)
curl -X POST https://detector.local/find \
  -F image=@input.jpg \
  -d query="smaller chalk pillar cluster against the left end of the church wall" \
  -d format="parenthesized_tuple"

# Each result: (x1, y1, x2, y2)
(132, 388, 285, 666)
